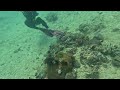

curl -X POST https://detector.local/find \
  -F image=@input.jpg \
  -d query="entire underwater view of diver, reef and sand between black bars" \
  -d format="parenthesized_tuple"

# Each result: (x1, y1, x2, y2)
(0, 11, 120, 79)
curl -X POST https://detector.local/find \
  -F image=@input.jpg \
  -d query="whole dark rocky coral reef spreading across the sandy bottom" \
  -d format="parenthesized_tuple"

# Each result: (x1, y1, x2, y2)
(37, 23, 120, 79)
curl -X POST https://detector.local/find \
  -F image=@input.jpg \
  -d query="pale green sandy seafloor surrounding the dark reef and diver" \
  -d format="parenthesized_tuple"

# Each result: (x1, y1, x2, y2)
(0, 11, 120, 79)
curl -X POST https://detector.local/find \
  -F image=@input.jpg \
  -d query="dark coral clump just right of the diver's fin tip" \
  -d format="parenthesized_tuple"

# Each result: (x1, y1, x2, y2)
(57, 33, 89, 48)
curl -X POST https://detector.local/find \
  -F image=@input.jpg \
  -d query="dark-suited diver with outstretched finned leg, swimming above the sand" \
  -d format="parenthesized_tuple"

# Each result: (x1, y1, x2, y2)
(22, 11, 63, 37)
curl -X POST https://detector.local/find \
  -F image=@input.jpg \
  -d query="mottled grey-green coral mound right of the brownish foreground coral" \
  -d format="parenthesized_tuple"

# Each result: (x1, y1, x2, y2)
(80, 50, 107, 67)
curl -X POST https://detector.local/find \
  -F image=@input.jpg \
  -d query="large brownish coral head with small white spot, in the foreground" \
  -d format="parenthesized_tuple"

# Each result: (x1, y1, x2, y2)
(45, 49, 75, 79)
